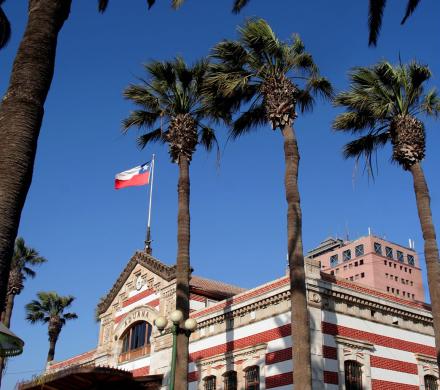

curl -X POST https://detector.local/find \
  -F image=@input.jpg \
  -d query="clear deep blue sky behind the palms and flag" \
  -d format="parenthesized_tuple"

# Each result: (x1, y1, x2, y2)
(0, 0, 440, 389)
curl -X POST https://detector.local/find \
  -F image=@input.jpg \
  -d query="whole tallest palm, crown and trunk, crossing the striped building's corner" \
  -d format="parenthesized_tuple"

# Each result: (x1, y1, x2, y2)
(207, 19, 332, 389)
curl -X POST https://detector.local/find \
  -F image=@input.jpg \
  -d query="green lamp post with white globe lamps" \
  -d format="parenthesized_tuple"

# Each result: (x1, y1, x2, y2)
(154, 310, 197, 390)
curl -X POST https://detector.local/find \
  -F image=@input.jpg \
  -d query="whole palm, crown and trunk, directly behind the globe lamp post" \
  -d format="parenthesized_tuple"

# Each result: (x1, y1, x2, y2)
(123, 58, 217, 390)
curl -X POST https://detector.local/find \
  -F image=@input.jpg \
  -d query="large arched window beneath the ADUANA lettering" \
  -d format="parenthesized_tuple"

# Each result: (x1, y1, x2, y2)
(119, 321, 152, 362)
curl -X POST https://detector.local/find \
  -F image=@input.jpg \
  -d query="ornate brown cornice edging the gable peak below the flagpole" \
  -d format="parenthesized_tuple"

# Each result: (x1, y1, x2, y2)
(96, 252, 176, 316)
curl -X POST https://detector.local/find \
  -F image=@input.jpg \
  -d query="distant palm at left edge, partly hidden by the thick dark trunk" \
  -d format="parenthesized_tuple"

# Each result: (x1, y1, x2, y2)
(0, 237, 47, 384)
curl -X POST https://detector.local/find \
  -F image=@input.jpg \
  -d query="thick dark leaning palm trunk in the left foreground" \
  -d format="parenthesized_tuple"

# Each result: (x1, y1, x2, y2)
(0, 0, 72, 310)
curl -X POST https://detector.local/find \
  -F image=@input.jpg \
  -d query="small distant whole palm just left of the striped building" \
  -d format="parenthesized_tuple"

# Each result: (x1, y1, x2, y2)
(26, 291, 78, 362)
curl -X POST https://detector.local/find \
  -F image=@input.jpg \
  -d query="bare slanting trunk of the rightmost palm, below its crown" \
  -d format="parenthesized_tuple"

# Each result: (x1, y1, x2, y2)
(410, 163, 440, 367)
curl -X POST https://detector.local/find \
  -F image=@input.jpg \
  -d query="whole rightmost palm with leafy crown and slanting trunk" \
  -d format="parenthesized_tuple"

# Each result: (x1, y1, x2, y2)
(333, 61, 440, 363)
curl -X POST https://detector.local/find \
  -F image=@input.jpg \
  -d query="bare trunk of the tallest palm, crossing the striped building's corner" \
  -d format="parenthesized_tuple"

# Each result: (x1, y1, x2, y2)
(282, 125, 312, 390)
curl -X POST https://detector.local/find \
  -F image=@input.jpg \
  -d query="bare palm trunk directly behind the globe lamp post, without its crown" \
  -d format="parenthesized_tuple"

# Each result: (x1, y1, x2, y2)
(174, 156, 190, 390)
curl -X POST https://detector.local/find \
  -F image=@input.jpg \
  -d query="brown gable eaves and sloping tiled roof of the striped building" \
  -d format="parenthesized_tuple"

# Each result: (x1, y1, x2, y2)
(96, 252, 245, 315)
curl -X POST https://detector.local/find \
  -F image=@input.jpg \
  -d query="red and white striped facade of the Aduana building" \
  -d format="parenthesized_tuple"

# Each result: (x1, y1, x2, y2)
(48, 253, 438, 390)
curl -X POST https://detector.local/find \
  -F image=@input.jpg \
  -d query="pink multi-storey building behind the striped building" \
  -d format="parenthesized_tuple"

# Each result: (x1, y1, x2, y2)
(307, 235, 425, 301)
